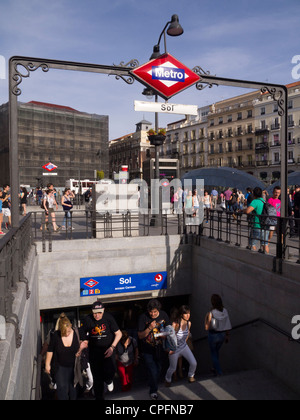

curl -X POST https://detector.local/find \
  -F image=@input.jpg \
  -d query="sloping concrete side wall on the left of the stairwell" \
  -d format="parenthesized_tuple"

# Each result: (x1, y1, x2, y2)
(0, 247, 40, 400)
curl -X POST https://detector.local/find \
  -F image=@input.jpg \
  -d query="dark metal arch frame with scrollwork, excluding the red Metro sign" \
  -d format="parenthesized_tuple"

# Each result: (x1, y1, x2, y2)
(9, 56, 288, 227)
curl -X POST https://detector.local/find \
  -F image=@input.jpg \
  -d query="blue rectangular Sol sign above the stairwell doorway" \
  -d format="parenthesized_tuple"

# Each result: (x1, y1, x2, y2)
(80, 271, 168, 297)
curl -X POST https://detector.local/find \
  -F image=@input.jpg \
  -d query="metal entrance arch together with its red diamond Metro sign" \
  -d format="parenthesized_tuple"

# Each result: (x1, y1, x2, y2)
(9, 54, 288, 228)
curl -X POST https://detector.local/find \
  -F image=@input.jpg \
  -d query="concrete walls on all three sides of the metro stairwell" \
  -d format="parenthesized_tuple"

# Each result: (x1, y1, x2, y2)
(0, 236, 300, 400)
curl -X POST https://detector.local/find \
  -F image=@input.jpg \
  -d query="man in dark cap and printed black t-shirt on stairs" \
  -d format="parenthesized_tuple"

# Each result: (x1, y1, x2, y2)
(80, 301, 122, 400)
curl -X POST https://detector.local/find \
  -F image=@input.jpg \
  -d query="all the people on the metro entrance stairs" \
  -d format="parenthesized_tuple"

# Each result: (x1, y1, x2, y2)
(42, 295, 232, 400)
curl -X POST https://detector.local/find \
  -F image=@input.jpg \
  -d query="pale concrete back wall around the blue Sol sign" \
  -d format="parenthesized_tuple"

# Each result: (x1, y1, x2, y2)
(38, 236, 192, 309)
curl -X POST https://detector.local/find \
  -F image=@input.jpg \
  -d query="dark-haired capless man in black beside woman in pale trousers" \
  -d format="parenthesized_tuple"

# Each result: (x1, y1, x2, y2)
(138, 299, 170, 400)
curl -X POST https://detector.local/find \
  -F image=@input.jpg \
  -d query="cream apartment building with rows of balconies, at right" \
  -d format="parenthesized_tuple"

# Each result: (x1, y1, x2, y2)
(161, 82, 300, 185)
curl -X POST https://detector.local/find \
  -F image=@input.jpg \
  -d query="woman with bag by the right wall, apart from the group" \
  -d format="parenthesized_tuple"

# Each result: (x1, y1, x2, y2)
(205, 295, 232, 376)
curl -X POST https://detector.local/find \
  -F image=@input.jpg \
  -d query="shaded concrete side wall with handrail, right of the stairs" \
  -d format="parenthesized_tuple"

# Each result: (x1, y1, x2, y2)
(191, 238, 300, 394)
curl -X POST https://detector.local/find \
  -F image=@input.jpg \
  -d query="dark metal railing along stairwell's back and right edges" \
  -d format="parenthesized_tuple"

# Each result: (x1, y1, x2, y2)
(32, 210, 300, 264)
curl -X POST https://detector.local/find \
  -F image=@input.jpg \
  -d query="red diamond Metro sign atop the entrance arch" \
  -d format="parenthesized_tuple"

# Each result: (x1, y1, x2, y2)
(132, 54, 200, 99)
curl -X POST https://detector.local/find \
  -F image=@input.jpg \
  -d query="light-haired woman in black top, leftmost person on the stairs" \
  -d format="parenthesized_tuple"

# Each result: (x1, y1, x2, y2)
(45, 314, 80, 400)
